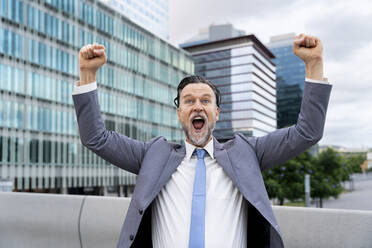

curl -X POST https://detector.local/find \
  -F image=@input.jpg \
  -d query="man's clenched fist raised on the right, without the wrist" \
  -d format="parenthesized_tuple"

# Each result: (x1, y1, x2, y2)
(293, 34, 323, 64)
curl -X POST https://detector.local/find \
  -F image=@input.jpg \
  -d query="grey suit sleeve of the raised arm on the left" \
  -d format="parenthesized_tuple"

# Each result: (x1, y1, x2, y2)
(73, 90, 150, 174)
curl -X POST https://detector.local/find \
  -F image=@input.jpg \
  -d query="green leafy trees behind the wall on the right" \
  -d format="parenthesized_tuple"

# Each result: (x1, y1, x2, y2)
(263, 148, 354, 205)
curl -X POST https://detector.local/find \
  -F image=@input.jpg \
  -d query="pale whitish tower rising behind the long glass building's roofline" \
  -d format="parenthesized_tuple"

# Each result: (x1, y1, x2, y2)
(99, 0, 169, 40)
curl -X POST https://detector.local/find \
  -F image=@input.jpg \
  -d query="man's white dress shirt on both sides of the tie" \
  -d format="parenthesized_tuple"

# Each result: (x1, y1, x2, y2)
(151, 139, 248, 248)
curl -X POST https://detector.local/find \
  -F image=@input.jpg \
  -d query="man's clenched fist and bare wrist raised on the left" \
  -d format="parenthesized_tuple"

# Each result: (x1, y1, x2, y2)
(79, 43, 107, 85)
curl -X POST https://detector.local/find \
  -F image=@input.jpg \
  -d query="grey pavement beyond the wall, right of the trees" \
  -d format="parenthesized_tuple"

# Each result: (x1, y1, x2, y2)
(316, 178, 372, 211)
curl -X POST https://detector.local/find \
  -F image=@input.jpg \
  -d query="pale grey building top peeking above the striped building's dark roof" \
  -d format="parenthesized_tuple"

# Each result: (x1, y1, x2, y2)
(180, 23, 245, 47)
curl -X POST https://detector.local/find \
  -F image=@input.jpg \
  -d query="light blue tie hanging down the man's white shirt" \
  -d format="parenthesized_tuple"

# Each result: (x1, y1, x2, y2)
(189, 149, 206, 248)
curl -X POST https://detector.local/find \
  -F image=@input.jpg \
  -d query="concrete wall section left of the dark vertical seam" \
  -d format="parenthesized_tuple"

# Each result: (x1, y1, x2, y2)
(0, 193, 83, 248)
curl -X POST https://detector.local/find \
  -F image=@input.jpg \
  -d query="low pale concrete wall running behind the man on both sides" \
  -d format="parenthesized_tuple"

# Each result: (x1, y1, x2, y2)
(0, 193, 372, 248)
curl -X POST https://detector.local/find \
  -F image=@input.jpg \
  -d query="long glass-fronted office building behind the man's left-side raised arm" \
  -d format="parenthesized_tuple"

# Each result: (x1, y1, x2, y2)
(0, 0, 194, 194)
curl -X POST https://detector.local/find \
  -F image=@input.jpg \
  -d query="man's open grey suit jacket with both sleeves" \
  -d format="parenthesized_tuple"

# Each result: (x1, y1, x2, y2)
(73, 82, 332, 248)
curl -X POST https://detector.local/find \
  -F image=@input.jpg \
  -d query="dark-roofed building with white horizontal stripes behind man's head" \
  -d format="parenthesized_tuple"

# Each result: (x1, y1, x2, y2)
(182, 35, 276, 141)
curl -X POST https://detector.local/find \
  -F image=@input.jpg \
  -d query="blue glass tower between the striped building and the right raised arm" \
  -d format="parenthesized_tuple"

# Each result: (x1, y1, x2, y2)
(267, 33, 305, 128)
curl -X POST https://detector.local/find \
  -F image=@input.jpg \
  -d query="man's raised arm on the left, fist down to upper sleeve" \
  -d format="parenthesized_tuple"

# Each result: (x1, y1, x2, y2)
(73, 44, 150, 174)
